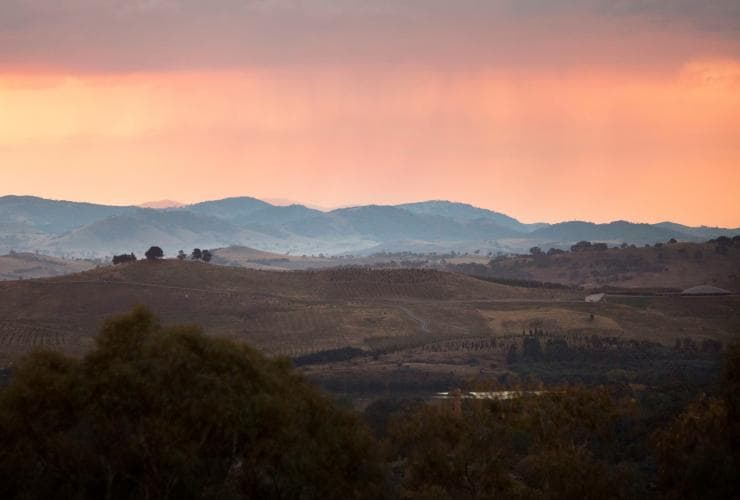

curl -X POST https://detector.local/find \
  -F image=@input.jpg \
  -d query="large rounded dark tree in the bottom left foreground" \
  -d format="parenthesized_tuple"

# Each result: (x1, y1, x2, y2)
(0, 308, 383, 498)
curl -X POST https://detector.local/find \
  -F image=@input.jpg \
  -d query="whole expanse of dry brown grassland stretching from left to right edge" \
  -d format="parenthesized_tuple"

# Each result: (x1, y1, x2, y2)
(0, 260, 740, 383)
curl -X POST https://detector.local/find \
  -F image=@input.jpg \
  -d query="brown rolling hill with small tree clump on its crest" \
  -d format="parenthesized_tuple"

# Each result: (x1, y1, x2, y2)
(0, 260, 553, 358)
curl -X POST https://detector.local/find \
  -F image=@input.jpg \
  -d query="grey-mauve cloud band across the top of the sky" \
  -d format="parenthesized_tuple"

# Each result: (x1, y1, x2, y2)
(0, 0, 740, 71)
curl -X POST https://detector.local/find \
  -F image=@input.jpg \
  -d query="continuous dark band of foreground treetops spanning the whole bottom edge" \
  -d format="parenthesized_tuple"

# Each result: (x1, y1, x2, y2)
(0, 308, 740, 499)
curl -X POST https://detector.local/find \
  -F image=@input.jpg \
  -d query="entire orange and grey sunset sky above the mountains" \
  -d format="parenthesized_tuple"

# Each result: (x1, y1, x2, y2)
(0, 0, 740, 227)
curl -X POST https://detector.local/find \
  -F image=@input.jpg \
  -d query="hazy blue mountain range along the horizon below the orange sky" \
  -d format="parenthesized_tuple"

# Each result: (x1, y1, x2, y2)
(0, 195, 740, 257)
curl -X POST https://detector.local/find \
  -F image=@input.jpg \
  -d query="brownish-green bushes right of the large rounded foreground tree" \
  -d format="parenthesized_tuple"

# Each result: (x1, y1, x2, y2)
(391, 389, 634, 499)
